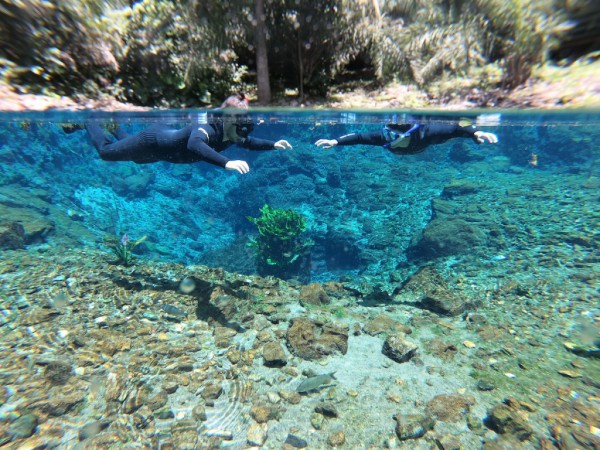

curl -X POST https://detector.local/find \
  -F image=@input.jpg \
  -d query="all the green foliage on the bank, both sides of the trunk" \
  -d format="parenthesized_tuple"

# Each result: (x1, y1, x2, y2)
(0, 0, 597, 101)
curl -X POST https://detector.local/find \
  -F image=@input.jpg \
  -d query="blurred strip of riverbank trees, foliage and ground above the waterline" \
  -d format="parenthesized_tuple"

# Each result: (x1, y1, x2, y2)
(0, 0, 600, 107)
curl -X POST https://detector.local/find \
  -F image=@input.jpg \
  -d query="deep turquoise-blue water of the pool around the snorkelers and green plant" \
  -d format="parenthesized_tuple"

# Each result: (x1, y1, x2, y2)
(0, 110, 600, 281)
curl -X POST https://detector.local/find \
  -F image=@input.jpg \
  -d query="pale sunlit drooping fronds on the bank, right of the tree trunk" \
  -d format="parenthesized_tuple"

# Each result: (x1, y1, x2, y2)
(370, 0, 567, 88)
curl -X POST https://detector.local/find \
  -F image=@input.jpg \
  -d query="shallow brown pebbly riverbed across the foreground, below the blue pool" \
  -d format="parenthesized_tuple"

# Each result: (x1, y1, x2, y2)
(0, 229, 600, 449)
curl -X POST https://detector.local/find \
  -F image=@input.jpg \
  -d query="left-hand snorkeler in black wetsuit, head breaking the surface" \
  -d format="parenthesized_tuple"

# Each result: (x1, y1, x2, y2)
(85, 96, 292, 173)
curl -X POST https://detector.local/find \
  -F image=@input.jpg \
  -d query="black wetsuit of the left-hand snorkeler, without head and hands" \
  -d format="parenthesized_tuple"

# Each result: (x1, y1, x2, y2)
(85, 120, 275, 167)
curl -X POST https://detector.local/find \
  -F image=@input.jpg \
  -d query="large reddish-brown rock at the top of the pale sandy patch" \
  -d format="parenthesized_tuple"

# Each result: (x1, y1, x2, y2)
(287, 318, 348, 360)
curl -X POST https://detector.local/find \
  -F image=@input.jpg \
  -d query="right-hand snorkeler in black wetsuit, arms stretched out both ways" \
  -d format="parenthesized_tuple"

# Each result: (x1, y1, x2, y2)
(315, 123, 498, 155)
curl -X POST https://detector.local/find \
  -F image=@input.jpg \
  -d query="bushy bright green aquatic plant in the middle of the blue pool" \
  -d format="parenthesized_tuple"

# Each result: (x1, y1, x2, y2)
(247, 204, 313, 279)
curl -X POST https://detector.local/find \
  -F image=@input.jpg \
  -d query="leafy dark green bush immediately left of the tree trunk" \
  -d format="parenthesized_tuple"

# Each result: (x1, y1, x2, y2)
(121, 0, 246, 106)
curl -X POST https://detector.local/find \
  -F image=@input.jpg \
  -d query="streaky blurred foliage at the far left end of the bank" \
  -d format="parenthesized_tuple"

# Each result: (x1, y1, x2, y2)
(0, 0, 121, 95)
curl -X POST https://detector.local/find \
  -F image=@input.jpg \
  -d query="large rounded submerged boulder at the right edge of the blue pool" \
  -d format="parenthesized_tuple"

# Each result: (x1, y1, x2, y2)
(407, 218, 486, 260)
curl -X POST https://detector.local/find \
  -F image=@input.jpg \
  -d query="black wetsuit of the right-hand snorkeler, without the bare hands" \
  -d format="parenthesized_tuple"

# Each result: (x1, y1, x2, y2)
(337, 123, 478, 155)
